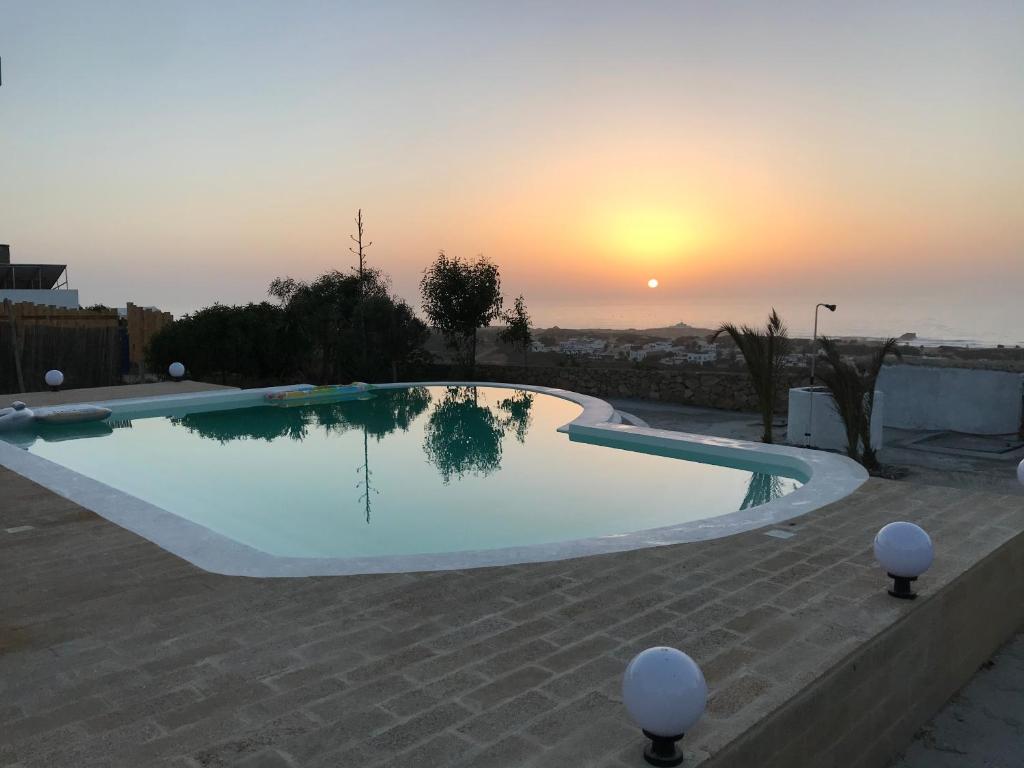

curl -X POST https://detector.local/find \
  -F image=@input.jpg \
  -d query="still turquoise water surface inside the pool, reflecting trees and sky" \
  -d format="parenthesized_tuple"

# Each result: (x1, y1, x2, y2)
(12, 387, 802, 557)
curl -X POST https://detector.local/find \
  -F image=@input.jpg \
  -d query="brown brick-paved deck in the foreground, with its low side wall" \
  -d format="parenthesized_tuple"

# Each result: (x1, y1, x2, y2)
(0, 385, 1024, 768)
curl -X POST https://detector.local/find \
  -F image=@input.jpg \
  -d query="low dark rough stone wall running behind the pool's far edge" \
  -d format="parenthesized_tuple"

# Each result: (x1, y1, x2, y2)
(428, 366, 807, 414)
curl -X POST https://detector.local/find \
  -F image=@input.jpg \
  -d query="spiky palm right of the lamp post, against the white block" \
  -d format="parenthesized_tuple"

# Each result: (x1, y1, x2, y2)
(820, 336, 900, 469)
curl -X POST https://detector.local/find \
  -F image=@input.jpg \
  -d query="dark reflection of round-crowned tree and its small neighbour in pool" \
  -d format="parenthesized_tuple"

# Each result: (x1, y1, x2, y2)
(423, 387, 534, 484)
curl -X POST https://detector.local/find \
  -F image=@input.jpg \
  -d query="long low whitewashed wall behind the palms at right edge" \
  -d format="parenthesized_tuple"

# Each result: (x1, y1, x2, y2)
(878, 366, 1024, 434)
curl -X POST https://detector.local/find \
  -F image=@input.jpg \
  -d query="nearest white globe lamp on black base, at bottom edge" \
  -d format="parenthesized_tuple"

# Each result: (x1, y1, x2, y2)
(623, 646, 708, 766)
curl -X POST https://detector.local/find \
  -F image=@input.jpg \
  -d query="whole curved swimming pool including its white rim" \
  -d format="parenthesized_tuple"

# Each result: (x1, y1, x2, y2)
(0, 383, 862, 575)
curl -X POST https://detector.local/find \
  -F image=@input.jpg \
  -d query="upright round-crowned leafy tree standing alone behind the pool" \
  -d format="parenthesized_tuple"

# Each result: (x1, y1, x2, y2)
(420, 251, 502, 374)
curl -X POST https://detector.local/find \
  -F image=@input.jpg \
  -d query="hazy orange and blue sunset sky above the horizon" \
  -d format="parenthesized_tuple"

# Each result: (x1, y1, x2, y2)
(0, 0, 1024, 340)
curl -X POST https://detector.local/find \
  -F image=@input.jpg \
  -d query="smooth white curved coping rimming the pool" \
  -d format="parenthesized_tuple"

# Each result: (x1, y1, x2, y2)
(0, 381, 867, 577)
